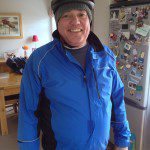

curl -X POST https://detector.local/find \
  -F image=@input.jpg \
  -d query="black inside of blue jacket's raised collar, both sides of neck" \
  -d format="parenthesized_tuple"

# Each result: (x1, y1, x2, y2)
(52, 30, 104, 52)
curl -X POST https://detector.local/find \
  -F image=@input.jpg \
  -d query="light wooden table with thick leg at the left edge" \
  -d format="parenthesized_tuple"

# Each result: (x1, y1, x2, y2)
(0, 73, 22, 135)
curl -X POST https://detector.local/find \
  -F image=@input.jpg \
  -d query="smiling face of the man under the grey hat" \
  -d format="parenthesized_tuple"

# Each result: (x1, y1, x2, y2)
(58, 10, 90, 48)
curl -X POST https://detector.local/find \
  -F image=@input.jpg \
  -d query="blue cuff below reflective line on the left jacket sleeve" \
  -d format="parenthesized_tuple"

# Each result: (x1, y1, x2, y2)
(18, 139, 40, 150)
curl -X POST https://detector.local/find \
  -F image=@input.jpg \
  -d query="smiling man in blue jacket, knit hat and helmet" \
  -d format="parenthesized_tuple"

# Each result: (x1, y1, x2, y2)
(18, 0, 130, 150)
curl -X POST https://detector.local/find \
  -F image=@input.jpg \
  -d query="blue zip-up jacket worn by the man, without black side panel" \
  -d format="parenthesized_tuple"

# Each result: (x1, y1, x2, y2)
(18, 32, 130, 150)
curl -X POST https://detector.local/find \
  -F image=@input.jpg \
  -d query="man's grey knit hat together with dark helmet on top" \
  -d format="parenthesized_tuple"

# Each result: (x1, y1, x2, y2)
(51, 0, 94, 24)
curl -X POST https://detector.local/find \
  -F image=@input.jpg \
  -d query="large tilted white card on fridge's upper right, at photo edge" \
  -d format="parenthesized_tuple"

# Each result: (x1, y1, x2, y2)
(135, 24, 150, 36)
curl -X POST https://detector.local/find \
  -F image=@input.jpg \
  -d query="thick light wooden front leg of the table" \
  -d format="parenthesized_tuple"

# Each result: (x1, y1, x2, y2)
(0, 90, 8, 135)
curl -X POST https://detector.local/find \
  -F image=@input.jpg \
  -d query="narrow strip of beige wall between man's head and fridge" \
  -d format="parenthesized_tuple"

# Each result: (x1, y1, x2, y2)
(94, 0, 110, 45)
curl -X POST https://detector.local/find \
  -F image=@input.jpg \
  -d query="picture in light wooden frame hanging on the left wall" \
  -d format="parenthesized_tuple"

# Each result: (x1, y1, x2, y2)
(0, 13, 23, 39)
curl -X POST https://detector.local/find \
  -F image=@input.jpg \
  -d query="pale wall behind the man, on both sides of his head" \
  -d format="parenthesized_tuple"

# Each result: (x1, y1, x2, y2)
(0, 0, 111, 57)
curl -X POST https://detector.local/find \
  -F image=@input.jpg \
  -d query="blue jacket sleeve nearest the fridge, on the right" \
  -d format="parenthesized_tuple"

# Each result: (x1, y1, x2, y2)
(111, 68, 130, 148)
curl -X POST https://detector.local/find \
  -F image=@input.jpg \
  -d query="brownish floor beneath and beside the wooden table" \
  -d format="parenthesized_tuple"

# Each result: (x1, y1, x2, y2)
(0, 116, 113, 150)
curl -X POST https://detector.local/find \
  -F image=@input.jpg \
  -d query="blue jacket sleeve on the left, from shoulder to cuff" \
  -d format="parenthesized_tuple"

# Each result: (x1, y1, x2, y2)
(18, 55, 41, 150)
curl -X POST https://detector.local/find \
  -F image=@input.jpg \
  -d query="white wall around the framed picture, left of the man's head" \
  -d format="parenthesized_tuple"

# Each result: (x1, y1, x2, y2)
(0, 0, 51, 56)
